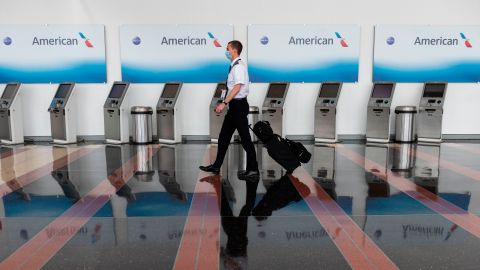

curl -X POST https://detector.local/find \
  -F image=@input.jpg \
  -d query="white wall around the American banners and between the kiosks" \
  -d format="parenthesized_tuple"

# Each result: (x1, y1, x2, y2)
(0, 0, 480, 137)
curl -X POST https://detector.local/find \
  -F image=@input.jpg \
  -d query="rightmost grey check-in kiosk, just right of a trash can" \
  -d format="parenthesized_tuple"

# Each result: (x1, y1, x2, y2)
(417, 82, 447, 142)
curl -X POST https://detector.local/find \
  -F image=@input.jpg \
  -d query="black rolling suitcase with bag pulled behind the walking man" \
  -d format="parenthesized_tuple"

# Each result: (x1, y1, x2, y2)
(252, 121, 311, 174)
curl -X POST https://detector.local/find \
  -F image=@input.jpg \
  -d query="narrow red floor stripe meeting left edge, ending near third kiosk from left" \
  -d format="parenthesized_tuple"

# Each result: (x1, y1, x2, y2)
(0, 147, 98, 198)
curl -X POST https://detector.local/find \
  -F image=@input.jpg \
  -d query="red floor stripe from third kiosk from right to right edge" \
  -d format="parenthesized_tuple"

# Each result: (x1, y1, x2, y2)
(336, 145, 480, 238)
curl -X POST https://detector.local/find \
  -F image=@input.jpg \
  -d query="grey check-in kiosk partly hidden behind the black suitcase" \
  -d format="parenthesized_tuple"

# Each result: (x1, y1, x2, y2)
(262, 82, 290, 136)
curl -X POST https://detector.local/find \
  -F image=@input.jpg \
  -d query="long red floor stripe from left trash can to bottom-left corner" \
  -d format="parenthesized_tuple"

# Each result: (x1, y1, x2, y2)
(0, 146, 158, 269)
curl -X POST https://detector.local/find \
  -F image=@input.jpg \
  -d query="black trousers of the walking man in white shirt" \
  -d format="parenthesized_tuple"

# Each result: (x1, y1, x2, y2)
(213, 98, 258, 171)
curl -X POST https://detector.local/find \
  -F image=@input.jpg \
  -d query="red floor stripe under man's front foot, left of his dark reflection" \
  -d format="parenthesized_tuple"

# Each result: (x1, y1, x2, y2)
(173, 148, 221, 270)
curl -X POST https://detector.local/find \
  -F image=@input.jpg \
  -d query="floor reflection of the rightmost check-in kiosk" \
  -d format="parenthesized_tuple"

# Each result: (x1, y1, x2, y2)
(413, 143, 440, 194)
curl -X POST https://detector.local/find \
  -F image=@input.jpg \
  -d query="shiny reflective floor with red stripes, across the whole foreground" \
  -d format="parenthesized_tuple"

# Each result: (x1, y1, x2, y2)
(0, 143, 480, 269)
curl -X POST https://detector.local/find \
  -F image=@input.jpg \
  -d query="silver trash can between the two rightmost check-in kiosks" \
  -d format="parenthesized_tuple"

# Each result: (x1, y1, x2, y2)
(395, 106, 417, 142)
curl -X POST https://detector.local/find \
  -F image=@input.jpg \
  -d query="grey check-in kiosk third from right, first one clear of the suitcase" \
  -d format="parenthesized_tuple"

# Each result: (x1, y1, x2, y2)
(314, 82, 342, 143)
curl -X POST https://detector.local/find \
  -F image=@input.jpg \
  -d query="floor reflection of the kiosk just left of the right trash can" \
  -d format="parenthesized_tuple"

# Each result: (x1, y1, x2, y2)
(365, 144, 391, 197)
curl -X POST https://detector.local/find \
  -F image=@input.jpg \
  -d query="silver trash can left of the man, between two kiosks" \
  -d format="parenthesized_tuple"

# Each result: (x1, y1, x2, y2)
(131, 106, 153, 144)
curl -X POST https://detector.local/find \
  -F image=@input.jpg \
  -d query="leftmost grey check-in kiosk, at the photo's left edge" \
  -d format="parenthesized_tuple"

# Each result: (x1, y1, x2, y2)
(0, 83, 23, 144)
